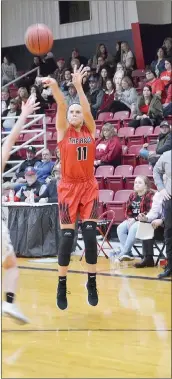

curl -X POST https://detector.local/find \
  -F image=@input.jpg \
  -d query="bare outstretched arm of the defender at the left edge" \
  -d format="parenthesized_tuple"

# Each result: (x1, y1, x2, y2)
(2, 97, 40, 172)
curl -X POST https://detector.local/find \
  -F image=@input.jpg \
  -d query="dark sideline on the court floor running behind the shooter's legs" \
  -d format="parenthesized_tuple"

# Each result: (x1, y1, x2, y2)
(18, 266, 171, 282)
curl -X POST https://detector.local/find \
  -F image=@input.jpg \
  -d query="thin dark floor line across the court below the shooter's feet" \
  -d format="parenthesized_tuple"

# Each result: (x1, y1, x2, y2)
(2, 328, 172, 333)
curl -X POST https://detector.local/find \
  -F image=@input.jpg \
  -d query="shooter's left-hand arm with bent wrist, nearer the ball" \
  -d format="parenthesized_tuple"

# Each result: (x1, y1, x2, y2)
(41, 77, 68, 141)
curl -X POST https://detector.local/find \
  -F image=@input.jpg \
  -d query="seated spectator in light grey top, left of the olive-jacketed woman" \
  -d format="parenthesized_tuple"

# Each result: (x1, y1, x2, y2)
(109, 76, 138, 113)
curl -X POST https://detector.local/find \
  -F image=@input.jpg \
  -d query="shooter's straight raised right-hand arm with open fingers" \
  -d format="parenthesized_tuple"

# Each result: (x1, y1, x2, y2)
(72, 65, 96, 137)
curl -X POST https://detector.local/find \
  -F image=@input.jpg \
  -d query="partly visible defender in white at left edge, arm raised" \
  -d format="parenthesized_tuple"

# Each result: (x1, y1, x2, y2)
(2, 98, 39, 324)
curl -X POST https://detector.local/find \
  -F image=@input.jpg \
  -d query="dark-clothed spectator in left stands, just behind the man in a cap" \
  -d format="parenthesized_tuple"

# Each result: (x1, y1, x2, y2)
(13, 146, 39, 183)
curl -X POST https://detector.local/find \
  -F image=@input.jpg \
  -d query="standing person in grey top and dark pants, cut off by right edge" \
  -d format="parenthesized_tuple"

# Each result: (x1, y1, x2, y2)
(153, 150, 172, 279)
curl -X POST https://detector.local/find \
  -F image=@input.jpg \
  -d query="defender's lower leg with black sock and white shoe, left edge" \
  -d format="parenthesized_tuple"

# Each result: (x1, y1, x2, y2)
(2, 254, 29, 324)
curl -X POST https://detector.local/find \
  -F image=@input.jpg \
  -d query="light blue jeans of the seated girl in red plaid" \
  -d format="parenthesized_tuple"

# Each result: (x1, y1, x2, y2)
(117, 220, 138, 254)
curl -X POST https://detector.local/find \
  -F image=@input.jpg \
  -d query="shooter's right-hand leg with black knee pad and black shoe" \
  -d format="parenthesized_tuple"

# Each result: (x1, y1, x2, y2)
(82, 219, 98, 306)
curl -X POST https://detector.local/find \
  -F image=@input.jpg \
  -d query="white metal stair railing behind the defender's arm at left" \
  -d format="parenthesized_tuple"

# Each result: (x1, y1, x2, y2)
(1, 114, 47, 177)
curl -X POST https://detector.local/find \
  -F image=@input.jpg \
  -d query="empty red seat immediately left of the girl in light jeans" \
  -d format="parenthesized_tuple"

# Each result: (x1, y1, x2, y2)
(106, 190, 133, 224)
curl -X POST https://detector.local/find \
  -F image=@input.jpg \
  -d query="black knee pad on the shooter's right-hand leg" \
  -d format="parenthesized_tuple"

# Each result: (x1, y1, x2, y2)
(82, 221, 97, 265)
